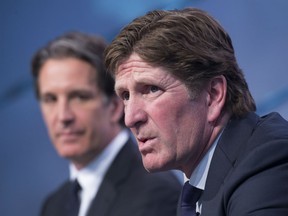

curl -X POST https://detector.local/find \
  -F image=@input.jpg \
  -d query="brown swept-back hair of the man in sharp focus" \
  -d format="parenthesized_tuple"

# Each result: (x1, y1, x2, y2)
(105, 8, 256, 117)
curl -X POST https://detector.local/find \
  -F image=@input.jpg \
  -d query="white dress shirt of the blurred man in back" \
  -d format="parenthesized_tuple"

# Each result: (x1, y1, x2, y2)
(69, 130, 129, 216)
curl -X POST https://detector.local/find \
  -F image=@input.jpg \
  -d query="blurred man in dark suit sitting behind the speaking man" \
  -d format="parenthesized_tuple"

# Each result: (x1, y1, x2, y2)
(32, 32, 181, 216)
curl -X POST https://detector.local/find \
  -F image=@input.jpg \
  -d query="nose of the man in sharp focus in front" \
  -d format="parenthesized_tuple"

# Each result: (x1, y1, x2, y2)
(125, 99, 147, 128)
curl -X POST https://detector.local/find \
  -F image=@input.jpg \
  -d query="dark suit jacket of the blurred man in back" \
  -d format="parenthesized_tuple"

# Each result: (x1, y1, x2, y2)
(41, 140, 181, 216)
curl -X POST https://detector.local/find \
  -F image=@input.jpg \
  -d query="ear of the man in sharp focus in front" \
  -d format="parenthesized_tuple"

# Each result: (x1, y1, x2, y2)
(207, 75, 227, 123)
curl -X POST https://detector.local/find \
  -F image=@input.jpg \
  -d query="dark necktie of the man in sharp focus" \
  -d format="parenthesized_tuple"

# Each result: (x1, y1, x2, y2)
(181, 181, 202, 216)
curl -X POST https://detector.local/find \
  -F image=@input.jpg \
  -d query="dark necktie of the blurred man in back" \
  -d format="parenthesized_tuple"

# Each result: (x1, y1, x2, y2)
(66, 179, 81, 216)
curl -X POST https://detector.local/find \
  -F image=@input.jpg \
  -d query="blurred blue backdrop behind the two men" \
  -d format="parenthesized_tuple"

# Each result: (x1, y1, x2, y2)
(0, 0, 288, 216)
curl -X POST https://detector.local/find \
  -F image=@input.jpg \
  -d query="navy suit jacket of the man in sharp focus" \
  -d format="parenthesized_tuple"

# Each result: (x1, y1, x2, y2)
(189, 113, 288, 216)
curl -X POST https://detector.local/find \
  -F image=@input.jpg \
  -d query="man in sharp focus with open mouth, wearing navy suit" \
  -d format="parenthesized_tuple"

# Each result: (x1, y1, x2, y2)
(105, 8, 288, 216)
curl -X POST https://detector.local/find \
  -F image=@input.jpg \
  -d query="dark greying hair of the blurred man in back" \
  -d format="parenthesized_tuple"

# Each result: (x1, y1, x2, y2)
(31, 31, 115, 98)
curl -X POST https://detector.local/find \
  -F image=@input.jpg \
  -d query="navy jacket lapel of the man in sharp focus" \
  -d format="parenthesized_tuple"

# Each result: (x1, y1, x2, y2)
(202, 113, 259, 215)
